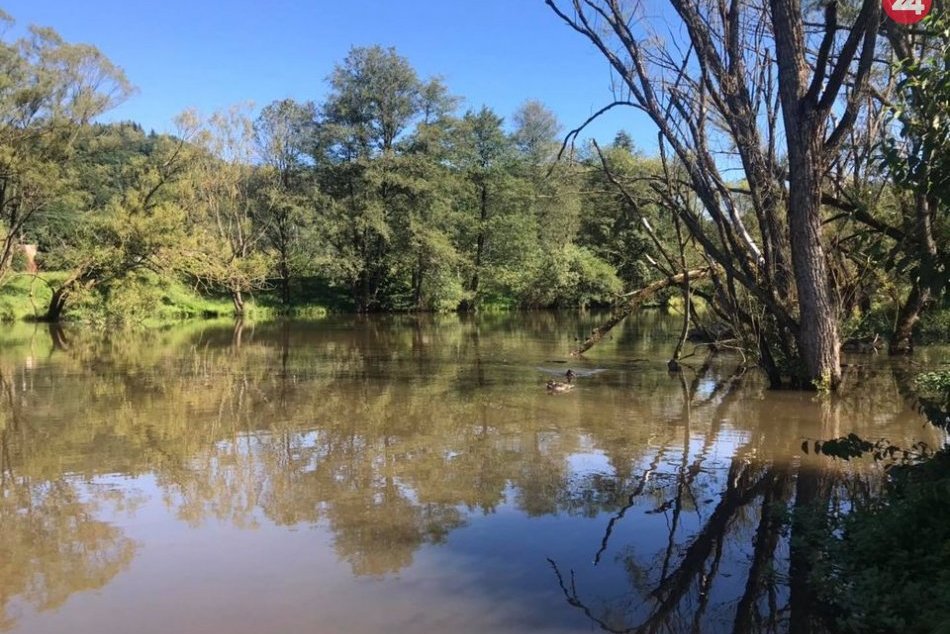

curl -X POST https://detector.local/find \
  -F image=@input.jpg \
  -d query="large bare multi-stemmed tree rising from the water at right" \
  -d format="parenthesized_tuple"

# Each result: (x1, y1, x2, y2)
(546, 0, 881, 388)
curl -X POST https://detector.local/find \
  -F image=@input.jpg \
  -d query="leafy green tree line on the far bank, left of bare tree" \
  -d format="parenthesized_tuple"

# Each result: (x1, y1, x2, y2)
(0, 16, 649, 321)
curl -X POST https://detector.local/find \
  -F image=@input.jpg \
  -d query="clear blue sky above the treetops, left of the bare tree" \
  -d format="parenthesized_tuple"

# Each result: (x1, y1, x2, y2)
(2, 0, 655, 148)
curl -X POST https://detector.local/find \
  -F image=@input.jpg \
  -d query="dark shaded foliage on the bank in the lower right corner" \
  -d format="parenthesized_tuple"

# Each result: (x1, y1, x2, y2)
(802, 369, 950, 633)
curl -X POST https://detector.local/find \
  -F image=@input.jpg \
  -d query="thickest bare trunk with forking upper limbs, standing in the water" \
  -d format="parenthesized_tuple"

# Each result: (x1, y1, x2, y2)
(770, 0, 881, 389)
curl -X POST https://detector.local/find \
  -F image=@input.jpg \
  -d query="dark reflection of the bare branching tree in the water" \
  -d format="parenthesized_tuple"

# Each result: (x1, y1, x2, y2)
(548, 363, 916, 633)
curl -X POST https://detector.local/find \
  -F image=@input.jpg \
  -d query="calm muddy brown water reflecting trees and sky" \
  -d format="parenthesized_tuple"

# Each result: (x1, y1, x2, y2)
(0, 313, 943, 634)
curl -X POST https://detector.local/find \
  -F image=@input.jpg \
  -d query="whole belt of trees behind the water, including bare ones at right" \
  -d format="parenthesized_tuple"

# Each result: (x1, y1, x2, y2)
(0, 6, 950, 388)
